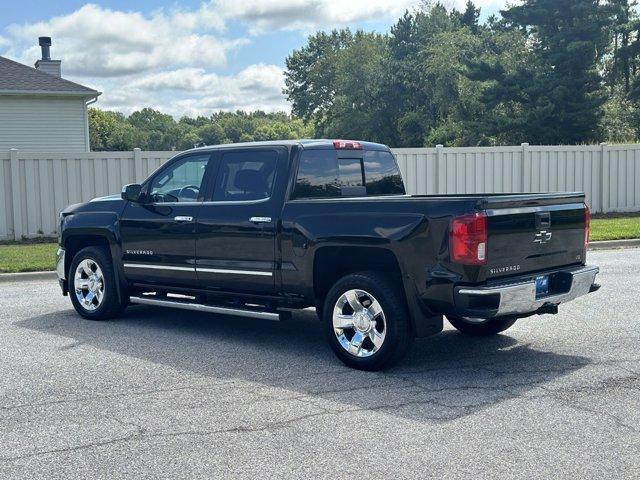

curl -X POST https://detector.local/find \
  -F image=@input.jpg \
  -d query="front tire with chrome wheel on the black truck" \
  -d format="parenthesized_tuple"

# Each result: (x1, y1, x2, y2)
(68, 247, 127, 320)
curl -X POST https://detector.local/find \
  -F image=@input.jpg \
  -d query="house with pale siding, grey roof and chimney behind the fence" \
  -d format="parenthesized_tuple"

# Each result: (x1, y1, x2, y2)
(0, 37, 100, 153)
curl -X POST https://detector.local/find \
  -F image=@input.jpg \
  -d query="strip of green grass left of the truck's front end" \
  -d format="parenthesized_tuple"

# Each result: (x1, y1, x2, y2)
(0, 243, 58, 273)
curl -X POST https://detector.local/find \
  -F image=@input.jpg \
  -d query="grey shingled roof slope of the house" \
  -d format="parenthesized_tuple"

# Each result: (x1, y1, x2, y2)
(0, 57, 100, 96)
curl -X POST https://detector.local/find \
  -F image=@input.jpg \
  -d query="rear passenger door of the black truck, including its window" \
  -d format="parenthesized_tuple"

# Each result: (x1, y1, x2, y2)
(196, 147, 287, 293)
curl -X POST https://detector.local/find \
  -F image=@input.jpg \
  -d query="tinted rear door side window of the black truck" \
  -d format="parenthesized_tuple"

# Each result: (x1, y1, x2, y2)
(213, 150, 278, 201)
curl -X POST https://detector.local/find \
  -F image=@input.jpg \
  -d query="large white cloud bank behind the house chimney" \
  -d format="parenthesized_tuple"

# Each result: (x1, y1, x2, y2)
(7, 3, 239, 77)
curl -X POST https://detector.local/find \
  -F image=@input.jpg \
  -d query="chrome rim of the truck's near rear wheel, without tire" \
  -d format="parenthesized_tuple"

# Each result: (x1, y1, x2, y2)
(333, 289, 387, 357)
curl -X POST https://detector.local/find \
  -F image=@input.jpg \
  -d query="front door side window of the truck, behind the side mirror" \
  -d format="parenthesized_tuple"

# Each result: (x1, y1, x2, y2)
(149, 154, 209, 203)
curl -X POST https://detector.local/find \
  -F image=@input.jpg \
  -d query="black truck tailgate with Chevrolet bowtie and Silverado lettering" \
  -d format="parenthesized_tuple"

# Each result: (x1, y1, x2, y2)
(482, 193, 585, 278)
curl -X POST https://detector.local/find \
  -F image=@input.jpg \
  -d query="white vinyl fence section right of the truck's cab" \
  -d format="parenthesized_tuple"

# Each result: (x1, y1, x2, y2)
(394, 143, 640, 212)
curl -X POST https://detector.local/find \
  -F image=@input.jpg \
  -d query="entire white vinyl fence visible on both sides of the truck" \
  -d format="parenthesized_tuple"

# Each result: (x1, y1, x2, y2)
(0, 144, 640, 239)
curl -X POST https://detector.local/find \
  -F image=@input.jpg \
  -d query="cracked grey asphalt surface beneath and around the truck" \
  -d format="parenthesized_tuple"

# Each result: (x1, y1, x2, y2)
(0, 249, 640, 479)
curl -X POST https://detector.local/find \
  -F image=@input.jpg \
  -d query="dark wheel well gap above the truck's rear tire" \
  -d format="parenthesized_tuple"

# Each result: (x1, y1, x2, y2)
(313, 247, 401, 300)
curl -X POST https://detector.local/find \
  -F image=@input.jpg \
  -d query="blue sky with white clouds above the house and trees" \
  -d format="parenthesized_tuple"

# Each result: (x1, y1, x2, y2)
(0, 0, 506, 118)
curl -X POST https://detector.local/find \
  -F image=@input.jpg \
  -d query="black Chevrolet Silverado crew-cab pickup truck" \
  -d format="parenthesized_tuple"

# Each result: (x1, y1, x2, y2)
(57, 140, 598, 370)
